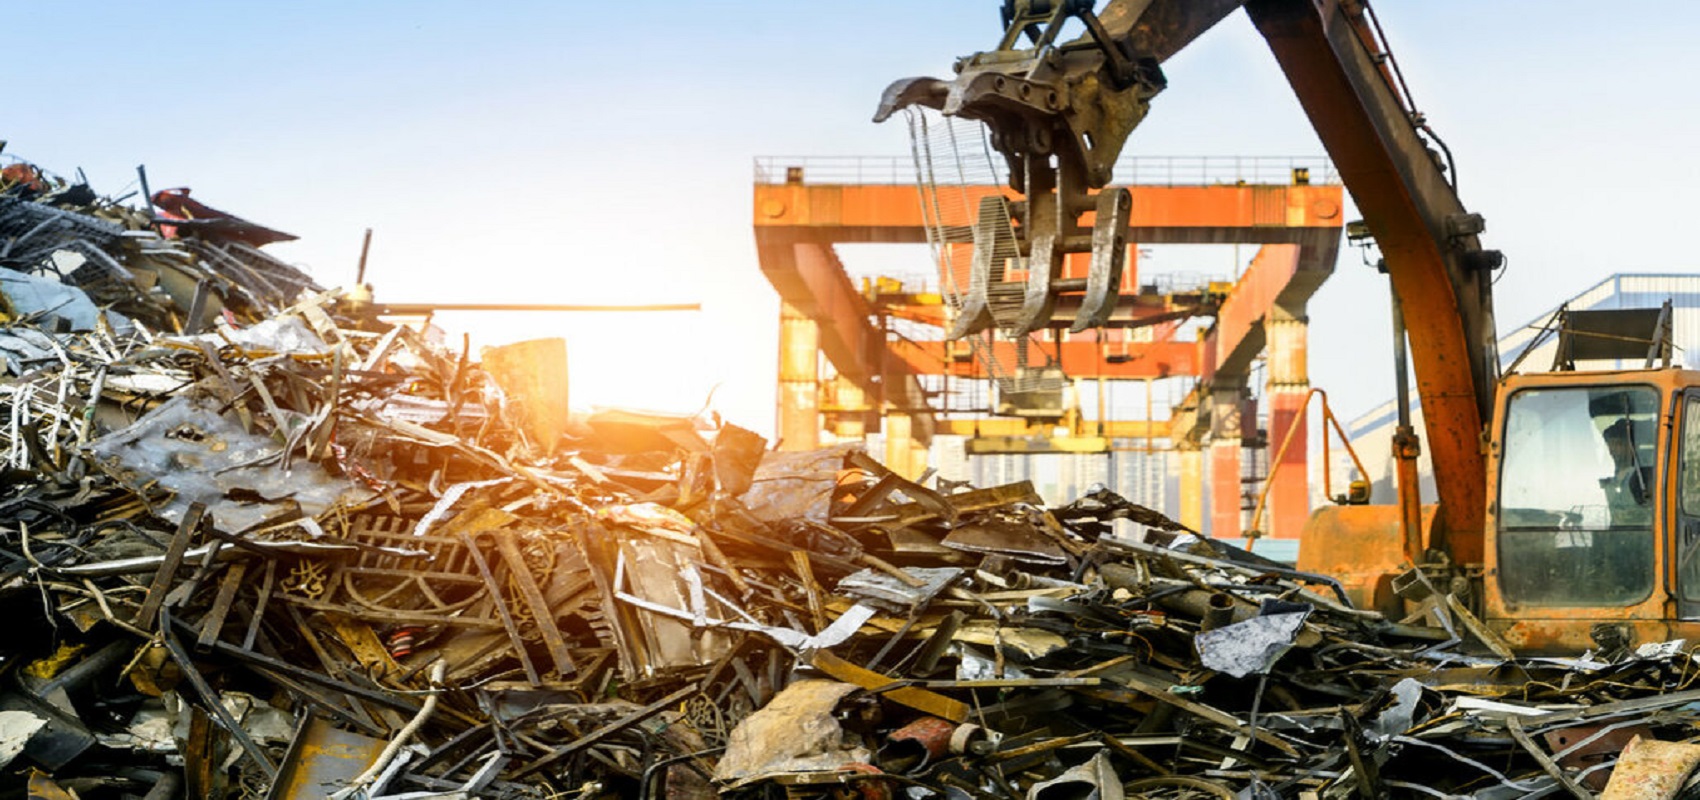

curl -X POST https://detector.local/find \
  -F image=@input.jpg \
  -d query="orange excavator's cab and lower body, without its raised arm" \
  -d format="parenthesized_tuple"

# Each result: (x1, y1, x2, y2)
(1297, 369, 1700, 654)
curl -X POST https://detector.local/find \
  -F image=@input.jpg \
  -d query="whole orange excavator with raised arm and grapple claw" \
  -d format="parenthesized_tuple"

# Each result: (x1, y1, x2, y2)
(876, 0, 1700, 654)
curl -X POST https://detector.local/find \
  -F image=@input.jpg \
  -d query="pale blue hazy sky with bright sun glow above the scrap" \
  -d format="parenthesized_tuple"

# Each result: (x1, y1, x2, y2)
(0, 0, 1700, 431)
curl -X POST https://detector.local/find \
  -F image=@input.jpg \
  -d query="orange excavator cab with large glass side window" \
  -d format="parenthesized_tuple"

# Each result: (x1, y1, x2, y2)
(1482, 369, 1700, 652)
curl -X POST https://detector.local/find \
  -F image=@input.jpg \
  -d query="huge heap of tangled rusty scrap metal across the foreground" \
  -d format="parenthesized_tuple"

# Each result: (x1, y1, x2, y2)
(0, 159, 1700, 800)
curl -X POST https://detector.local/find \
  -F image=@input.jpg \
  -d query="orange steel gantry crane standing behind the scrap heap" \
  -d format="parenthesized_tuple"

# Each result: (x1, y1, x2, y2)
(753, 158, 1343, 538)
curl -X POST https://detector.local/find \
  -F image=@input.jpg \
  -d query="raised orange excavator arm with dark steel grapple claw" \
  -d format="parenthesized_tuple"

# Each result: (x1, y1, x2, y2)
(876, 0, 1501, 562)
